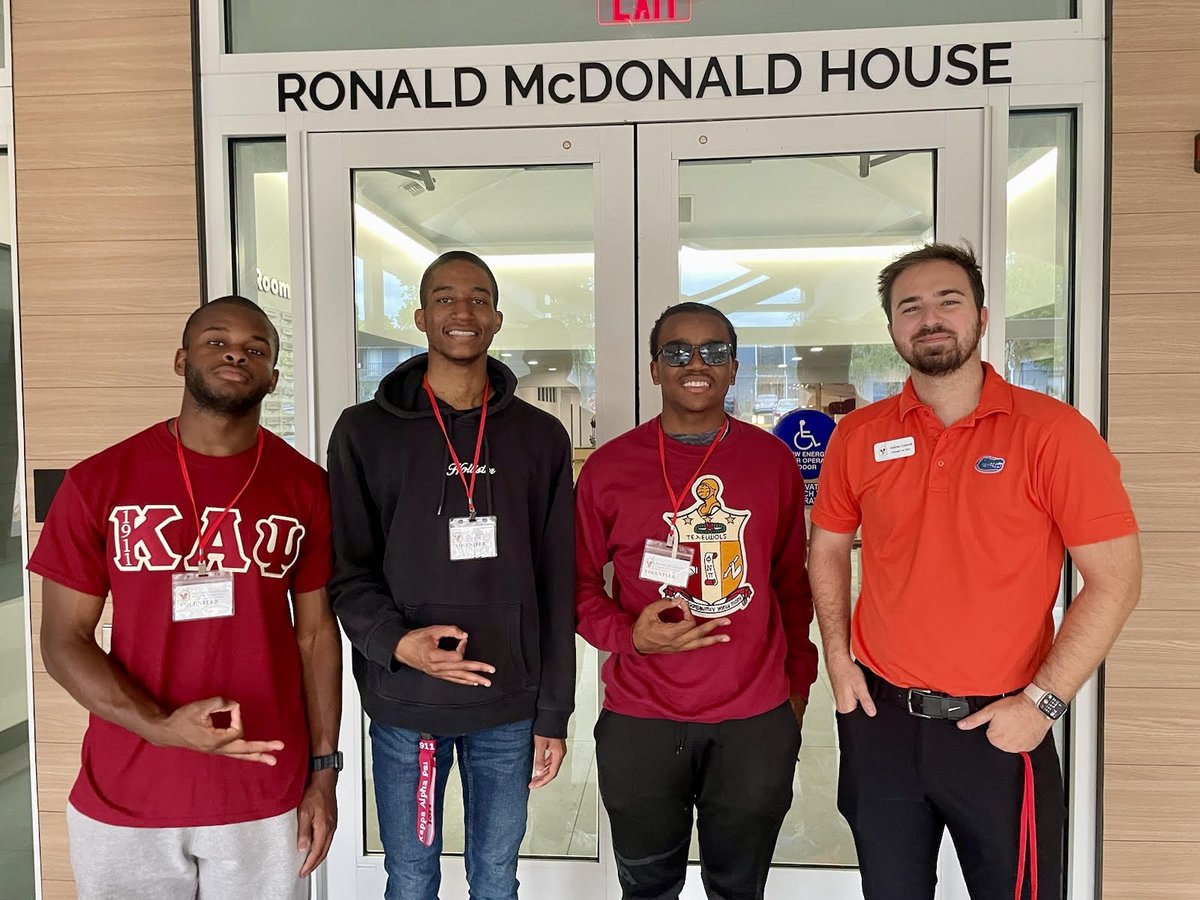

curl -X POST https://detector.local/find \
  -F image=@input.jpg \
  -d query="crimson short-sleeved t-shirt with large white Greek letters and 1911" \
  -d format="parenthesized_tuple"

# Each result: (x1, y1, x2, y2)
(29, 422, 331, 828)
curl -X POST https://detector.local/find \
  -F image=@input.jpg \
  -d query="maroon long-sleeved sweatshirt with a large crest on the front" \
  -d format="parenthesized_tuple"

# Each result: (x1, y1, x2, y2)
(575, 419, 817, 722)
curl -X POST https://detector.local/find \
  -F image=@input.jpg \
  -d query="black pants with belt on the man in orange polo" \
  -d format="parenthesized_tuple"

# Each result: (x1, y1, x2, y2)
(838, 676, 1066, 900)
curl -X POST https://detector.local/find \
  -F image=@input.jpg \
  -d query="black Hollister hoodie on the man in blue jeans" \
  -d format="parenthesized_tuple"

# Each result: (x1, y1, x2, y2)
(328, 354, 575, 738)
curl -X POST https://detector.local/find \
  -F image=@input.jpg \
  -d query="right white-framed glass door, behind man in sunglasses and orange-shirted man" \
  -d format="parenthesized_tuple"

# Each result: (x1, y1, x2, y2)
(637, 109, 986, 900)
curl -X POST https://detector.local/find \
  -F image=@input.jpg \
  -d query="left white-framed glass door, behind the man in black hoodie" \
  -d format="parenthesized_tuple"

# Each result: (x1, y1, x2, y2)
(308, 127, 635, 900)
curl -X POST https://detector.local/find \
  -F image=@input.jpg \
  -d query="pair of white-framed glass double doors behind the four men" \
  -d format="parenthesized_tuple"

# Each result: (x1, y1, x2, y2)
(306, 110, 986, 900)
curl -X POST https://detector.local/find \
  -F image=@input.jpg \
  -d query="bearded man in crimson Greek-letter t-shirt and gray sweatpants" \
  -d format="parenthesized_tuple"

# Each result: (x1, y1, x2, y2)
(29, 296, 341, 900)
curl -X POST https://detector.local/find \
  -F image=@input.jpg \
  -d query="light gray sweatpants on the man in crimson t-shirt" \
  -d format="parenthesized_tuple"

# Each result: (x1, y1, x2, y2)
(67, 804, 308, 900)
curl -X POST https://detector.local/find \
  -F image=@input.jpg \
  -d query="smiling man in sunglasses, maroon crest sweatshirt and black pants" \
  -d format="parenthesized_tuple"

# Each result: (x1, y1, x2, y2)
(575, 302, 817, 900)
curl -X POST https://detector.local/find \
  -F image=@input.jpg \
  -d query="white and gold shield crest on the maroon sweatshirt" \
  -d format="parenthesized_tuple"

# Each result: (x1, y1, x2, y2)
(659, 475, 754, 619)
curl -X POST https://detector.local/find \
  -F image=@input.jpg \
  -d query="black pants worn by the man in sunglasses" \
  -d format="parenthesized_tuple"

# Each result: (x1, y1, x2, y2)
(595, 703, 800, 900)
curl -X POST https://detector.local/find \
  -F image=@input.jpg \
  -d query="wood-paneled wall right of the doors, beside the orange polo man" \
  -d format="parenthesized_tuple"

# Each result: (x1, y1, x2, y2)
(1103, 0, 1200, 900)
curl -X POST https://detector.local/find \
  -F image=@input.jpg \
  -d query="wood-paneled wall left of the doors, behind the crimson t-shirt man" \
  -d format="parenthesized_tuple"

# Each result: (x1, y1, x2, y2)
(11, 0, 200, 898)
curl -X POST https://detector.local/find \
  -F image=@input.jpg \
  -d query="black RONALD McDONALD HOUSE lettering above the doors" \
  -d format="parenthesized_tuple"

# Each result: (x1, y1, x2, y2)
(276, 41, 1013, 113)
